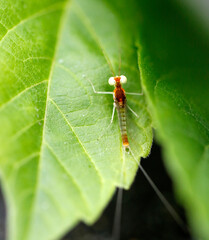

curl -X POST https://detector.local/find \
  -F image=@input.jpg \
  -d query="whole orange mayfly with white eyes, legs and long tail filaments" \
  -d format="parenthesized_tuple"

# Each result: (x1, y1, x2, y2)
(89, 75, 187, 240)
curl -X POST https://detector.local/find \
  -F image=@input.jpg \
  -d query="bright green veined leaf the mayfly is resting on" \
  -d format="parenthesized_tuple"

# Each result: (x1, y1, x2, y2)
(0, 0, 152, 240)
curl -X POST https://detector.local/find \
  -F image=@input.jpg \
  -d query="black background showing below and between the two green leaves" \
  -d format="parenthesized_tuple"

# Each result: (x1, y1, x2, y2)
(0, 143, 191, 240)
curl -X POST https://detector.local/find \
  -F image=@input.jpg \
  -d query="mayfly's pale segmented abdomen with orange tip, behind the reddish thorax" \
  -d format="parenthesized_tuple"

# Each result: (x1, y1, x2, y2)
(115, 101, 129, 147)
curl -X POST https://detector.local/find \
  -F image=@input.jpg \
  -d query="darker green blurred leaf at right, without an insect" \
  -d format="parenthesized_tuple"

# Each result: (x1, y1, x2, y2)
(136, 1, 209, 239)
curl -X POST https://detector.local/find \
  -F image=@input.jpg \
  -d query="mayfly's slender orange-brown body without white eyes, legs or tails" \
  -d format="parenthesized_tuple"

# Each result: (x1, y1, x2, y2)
(113, 76, 129, 148)
